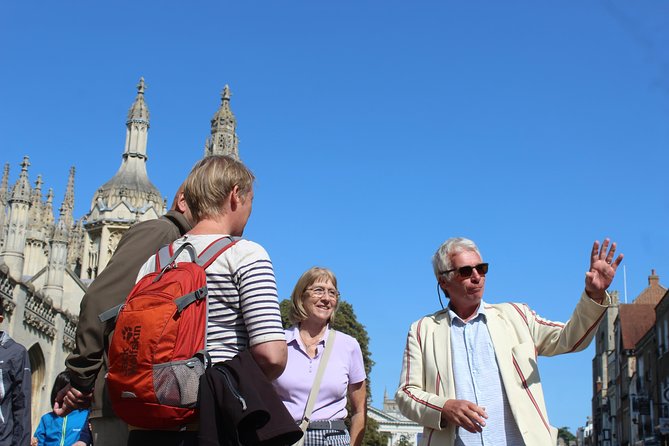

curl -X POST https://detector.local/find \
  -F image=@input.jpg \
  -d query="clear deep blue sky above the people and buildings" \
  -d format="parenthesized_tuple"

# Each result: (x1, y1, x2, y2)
(0, 0, 669, 430)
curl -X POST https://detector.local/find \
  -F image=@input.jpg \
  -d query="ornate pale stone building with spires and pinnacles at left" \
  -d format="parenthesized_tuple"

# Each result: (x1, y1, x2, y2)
(0, 79, 239, 426)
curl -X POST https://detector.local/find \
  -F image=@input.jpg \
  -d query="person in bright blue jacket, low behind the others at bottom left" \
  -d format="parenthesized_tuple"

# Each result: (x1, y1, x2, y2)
(32, 371, 88, 446)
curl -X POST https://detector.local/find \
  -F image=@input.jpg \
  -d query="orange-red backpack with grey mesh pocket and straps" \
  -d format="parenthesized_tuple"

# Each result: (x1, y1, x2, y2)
(100, 237, 239, 429)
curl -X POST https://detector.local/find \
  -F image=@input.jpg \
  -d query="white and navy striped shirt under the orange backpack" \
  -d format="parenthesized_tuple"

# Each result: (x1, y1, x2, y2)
(138, 234, 286, 363)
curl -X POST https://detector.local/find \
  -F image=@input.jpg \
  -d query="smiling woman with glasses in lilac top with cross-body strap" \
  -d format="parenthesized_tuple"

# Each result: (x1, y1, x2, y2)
(274, 267, 367, 446)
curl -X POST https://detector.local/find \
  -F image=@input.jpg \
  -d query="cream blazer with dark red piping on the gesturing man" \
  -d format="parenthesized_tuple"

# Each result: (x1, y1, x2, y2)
(395, 293, 610, 446)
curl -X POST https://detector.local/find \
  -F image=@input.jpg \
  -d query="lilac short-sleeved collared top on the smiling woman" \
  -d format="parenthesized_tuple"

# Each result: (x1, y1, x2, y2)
(273, 326, 367, 421)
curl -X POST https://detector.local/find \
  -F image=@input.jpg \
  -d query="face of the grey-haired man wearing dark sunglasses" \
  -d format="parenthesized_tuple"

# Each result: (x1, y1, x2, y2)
(439, 251, 485, 309)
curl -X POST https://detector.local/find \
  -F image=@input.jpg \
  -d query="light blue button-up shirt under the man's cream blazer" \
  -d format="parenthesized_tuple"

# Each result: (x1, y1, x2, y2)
(448, 301, 525, 446)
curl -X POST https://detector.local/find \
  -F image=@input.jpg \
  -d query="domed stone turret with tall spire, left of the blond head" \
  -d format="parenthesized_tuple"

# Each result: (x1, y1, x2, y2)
(80, 78, 165, 279)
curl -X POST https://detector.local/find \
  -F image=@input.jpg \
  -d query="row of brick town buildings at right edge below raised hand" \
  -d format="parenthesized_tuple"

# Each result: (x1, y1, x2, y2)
(592, 270, 669, 446)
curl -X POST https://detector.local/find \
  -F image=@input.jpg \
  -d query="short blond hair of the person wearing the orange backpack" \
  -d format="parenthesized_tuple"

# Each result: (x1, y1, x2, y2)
(183, 155, 255, 222)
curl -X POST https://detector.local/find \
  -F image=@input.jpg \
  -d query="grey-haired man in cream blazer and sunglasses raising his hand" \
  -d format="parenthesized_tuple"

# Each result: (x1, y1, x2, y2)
(395, 238, 623, 446)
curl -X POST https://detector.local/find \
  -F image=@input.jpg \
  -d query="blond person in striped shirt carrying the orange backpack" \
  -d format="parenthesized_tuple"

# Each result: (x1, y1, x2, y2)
(128, 155, 287, 446)
